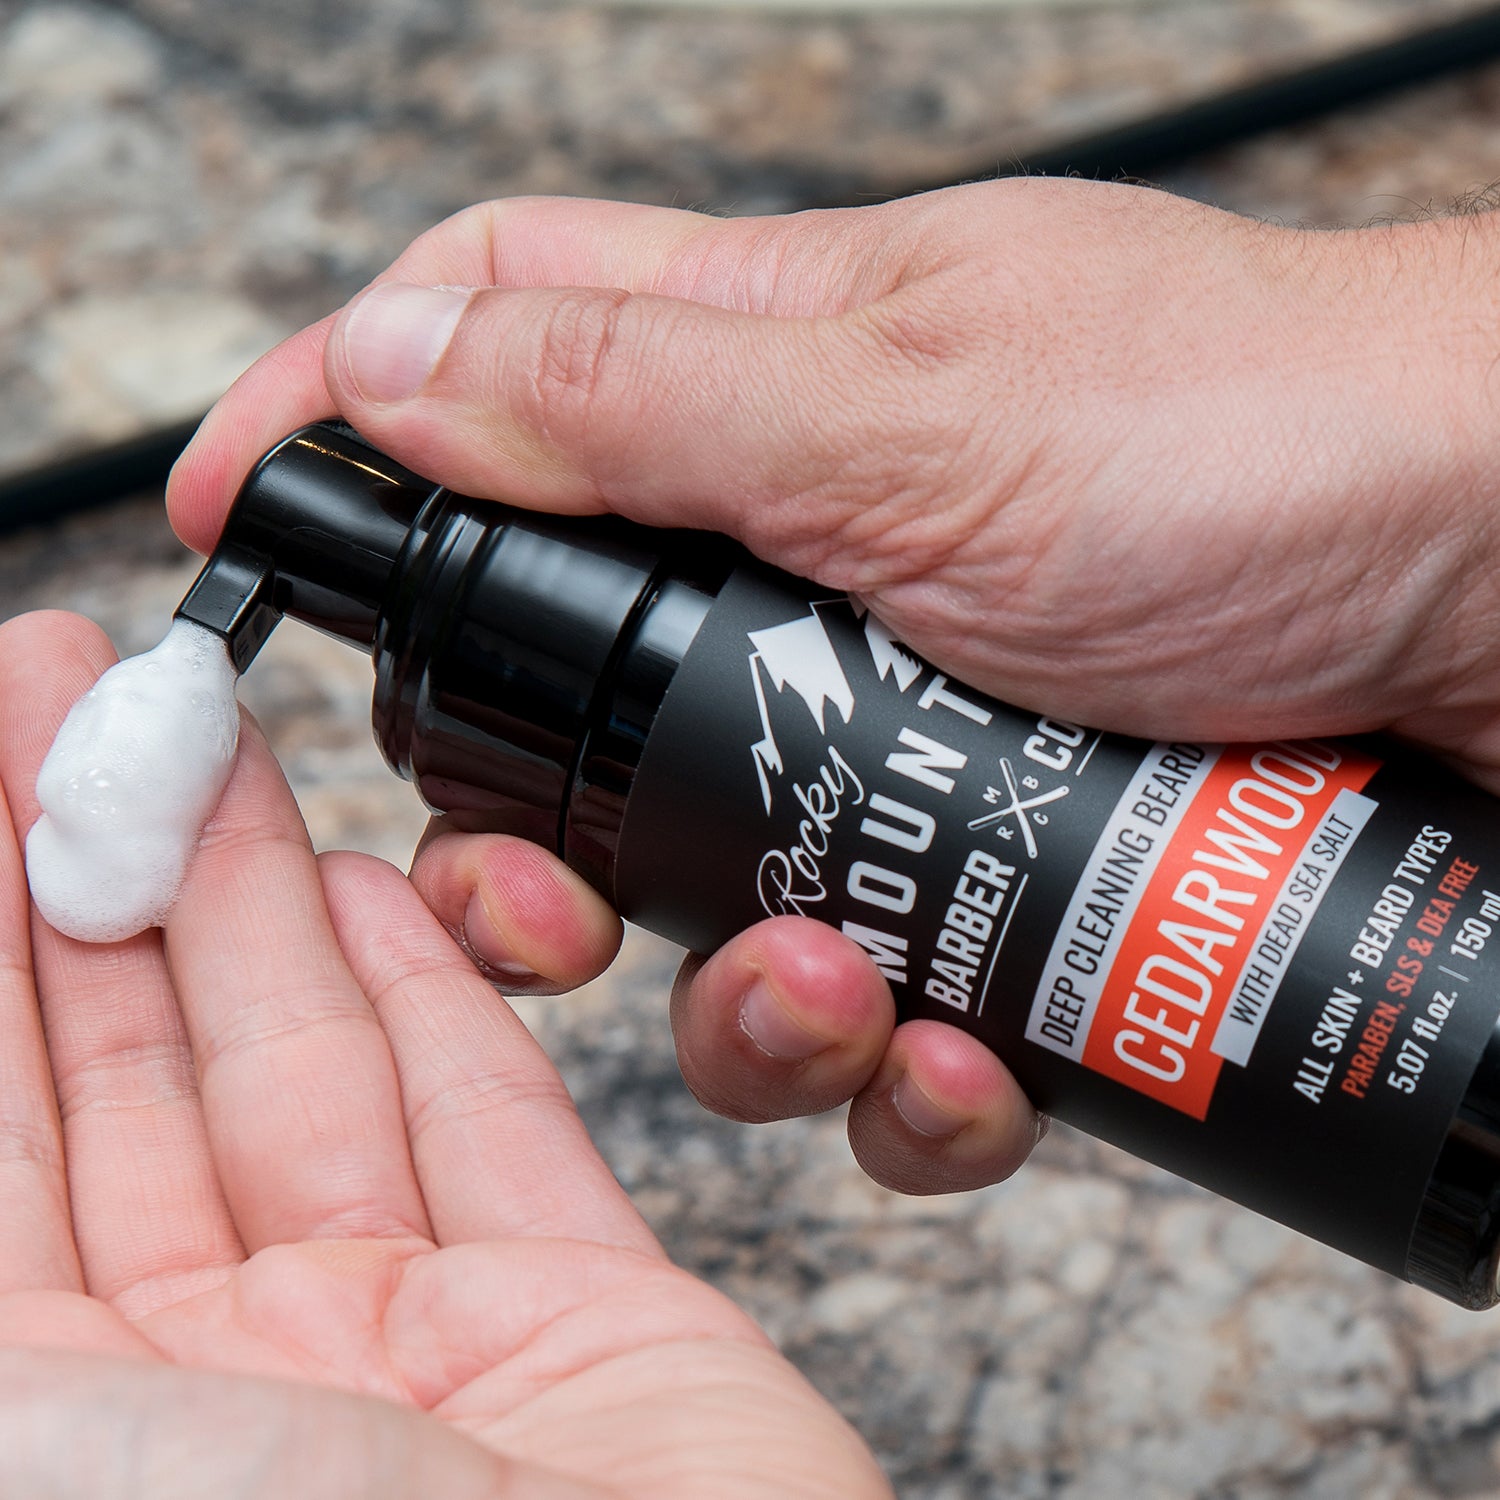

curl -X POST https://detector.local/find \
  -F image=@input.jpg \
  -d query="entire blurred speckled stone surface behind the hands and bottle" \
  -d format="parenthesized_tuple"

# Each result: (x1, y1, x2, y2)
(0, 0, 1500, 1500)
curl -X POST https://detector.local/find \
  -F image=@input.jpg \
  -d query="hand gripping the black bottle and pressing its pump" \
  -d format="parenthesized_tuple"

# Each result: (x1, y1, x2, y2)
(170, 180, 1500, 1191)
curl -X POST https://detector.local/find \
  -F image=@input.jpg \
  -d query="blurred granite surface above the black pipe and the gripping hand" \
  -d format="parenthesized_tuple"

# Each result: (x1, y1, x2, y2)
(0, 0, 1485, 474)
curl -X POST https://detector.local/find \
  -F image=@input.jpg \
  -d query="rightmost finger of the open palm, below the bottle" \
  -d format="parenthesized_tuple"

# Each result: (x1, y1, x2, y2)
(323, 854, 657, 1253)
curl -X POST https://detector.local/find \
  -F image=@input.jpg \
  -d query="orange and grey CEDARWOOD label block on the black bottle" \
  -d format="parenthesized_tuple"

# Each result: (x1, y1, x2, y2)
(1028, 741, 1380, 1119)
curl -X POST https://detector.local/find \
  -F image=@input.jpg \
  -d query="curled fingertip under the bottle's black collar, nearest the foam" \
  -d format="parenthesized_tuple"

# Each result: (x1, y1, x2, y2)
(411, 819, 624, 995)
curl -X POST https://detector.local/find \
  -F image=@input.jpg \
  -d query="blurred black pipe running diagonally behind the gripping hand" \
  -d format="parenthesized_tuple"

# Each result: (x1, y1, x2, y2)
(0, 6, 1500, 534)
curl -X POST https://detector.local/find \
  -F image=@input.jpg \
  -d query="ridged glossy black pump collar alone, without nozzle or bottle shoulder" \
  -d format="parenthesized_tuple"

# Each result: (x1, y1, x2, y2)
(374, 494, 659, 852)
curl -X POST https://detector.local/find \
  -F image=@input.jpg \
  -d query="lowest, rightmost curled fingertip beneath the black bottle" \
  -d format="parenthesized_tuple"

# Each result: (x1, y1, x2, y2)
(849, 1020, 1046, 1194)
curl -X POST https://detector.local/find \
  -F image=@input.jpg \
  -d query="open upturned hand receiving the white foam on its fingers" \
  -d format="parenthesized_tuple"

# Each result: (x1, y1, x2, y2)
(0, 615, 890, 1500)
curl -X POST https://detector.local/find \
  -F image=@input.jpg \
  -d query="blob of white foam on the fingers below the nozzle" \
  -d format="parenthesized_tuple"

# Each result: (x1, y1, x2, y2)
(26, 620, 240, 942)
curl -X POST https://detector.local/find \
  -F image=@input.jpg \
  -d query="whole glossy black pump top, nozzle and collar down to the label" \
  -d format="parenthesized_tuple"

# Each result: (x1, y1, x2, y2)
(177, 423, 740, 876)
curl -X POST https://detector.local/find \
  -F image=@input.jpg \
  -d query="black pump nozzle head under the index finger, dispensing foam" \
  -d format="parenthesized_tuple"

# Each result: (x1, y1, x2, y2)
(176, 422, 437, 672)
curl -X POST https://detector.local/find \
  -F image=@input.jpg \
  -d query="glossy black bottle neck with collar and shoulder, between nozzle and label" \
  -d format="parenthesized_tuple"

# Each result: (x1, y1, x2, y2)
(374, 492, 737, 896)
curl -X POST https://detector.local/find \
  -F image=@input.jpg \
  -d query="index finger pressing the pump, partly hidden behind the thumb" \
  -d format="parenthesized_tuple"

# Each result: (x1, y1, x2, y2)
(167, 198, 929, 552)
